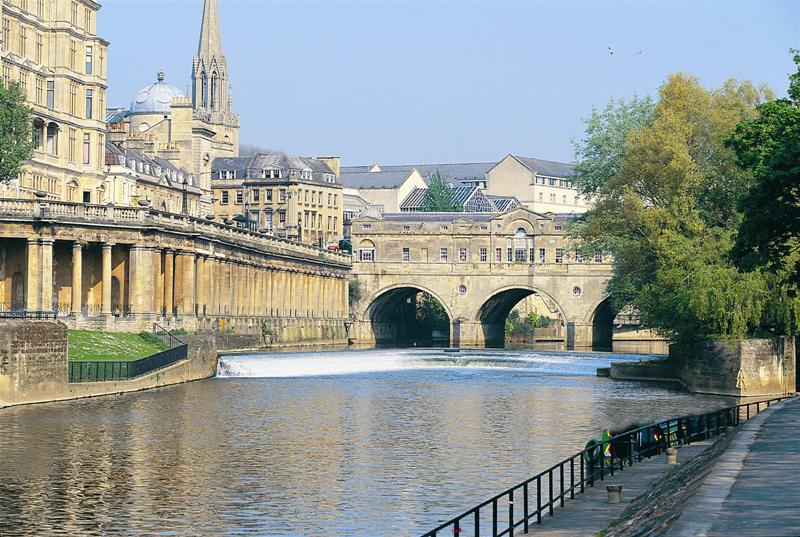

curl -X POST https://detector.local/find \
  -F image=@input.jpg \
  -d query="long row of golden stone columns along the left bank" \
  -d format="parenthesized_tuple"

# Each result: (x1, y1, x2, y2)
(18, 238, 348, 319)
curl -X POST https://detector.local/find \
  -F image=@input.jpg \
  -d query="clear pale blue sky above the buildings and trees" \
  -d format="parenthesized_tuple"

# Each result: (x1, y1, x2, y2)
(98, 0, 800, 164)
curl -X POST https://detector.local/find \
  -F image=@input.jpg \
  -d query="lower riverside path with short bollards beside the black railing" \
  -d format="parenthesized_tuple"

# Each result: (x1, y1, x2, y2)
(515, 441, 712, 537)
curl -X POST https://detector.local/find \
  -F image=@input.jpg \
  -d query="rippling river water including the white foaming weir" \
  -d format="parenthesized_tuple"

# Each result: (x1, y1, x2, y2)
(0, 350, 731, 537)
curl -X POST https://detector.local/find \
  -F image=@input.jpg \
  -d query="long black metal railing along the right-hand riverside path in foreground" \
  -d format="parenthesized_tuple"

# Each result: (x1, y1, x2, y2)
(422, 395, 793, 537)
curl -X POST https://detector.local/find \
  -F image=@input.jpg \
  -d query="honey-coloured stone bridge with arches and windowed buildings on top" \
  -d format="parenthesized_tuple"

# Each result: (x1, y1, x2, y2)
(350, 209, 615, 347)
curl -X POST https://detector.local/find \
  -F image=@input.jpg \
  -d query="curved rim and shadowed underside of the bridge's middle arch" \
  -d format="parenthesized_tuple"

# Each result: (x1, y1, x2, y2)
(470, 285, 568, 347)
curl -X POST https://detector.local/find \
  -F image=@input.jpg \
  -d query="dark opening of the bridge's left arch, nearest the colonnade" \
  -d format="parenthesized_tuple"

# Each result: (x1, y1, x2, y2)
(365, 286, 452, 346)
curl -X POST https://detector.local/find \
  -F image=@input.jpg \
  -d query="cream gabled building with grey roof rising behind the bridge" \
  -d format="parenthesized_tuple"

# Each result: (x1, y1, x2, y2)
(486, 155, 591, 214)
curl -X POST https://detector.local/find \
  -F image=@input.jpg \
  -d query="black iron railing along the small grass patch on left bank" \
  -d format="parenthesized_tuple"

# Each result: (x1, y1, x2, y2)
(69, 344, 189, 382)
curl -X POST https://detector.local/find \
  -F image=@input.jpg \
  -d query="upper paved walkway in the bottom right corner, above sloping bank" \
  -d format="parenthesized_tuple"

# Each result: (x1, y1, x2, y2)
(668, 399, 800, 537)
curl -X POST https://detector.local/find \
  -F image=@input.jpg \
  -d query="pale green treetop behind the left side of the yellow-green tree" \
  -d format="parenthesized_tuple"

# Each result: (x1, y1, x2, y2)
(572, 95, 655, 194)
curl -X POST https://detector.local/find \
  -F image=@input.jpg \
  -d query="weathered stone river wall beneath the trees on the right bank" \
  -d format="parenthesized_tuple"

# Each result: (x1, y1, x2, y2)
(669, 337, 797, 397)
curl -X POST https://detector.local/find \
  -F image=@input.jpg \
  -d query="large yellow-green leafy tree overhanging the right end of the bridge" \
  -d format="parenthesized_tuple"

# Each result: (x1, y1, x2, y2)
(577, 74, 785, 340)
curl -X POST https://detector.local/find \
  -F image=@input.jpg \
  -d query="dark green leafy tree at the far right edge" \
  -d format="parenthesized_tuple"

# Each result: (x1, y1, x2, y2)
(728, 51, 800, 286)
